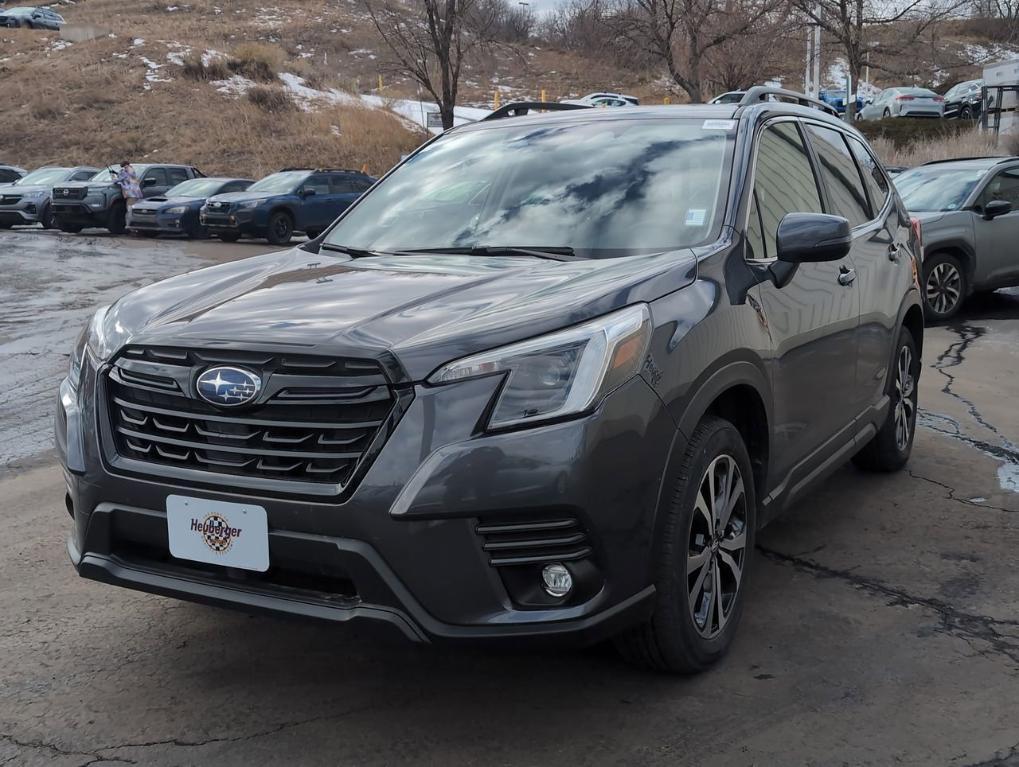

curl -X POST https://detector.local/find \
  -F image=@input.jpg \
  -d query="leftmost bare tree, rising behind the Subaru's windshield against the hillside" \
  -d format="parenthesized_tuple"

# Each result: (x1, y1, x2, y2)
(363, 0, 500, 128)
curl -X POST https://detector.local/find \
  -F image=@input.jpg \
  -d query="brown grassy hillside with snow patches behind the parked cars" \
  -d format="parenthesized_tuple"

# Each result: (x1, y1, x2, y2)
(0, 0, 1011, 176)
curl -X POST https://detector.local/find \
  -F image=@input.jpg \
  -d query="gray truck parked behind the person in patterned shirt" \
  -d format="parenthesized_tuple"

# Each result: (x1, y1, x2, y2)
(53, 163, 202, 234)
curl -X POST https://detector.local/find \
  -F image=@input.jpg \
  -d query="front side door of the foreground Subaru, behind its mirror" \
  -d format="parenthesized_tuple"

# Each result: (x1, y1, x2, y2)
(747, 118, 860, 487)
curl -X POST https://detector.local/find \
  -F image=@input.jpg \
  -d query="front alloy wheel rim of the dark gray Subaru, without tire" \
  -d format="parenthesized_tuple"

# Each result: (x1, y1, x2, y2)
(687, 454, 747, 639)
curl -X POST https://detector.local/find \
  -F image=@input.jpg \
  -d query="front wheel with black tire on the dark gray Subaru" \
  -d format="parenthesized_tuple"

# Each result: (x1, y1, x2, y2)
(615, 416, 757, 673)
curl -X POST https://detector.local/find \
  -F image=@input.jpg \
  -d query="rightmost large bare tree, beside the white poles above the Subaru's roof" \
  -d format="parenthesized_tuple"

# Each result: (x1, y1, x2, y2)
(792, 0, 969, 120)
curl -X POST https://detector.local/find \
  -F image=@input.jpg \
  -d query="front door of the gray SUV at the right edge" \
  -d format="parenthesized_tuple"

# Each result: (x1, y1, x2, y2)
(972, 165, 1019, 287)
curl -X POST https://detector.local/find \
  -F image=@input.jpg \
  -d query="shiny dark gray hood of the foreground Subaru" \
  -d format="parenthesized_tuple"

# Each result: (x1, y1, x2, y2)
(99, 248, 697, 380)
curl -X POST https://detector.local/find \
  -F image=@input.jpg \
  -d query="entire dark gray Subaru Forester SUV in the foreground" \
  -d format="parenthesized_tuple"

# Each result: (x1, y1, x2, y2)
(56, 89, 923, 672)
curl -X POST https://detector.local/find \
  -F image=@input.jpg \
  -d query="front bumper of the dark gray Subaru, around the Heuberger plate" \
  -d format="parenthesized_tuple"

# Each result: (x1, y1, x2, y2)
(56, 362, 677, 644)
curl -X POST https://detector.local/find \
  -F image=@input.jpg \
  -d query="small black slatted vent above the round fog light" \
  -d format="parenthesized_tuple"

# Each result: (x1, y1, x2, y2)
(475, 515, 592, 567)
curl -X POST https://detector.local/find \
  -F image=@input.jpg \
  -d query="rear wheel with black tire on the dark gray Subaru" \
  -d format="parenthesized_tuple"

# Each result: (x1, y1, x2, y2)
(853, 328, 920, 472)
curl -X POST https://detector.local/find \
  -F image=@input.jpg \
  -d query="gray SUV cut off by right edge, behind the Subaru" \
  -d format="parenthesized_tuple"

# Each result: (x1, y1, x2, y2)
(895, 157, 1019, 320)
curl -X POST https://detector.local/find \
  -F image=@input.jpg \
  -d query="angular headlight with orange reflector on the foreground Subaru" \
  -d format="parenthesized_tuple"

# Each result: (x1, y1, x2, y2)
(428, 304, 651, 429)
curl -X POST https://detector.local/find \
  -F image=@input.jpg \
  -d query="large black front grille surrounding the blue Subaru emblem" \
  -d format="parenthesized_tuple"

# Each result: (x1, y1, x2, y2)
(106, 347, 397, 489)
